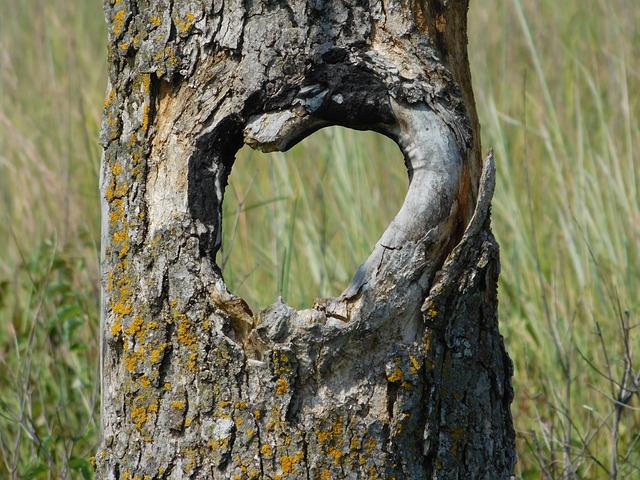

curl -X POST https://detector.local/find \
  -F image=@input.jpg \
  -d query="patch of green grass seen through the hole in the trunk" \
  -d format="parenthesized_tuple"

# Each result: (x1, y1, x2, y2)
(217, 127, 407, 309)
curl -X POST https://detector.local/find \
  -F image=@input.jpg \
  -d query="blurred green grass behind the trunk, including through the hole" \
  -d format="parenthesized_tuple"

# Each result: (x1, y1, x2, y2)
(0, 0, 640, 478)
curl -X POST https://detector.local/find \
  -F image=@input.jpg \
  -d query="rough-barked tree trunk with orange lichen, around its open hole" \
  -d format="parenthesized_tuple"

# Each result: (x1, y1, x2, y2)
(96, 0, 515, 479)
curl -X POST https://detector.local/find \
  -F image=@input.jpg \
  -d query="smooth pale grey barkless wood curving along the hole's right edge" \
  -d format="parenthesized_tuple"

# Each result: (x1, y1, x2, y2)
(340, 101, 463, 300)
